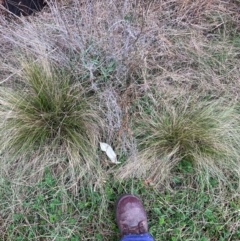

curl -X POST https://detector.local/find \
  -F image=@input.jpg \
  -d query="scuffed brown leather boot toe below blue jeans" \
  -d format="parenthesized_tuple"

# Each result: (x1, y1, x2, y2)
(116, 194, 148, 236)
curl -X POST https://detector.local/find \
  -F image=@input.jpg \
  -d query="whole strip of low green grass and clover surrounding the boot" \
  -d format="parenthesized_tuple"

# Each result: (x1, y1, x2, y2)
(0, 169, 240, 241)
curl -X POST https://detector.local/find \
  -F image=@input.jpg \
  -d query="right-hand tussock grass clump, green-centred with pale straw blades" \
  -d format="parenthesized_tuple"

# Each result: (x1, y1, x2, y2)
(117, 93, 240, 187)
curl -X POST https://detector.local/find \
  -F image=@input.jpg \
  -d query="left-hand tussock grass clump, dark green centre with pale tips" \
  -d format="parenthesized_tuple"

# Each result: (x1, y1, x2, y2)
(0, 62, 102, 168)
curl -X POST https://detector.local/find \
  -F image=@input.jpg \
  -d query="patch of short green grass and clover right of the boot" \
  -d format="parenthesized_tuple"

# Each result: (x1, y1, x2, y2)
(150, 189, 240, 241)
